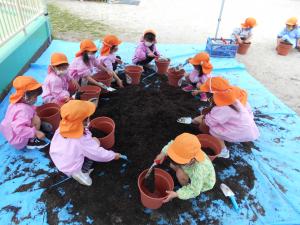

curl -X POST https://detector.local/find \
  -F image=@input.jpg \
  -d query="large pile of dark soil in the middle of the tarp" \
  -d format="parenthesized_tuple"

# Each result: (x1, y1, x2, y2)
(41, 76, 255, 225)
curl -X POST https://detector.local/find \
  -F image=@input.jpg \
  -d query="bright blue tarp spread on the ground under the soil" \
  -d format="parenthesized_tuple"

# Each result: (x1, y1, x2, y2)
(0, 40, 300, 225)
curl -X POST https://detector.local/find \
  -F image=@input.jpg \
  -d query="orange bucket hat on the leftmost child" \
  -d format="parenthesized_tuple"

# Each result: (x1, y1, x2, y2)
(9, 76, 42, 104)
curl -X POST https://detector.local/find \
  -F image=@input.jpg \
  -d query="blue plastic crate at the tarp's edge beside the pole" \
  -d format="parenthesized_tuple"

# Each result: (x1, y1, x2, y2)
(205, 38, 239, 58)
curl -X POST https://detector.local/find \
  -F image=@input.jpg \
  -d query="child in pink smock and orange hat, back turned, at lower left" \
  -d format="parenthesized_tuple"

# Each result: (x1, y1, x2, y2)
(50, 100, 120, 186)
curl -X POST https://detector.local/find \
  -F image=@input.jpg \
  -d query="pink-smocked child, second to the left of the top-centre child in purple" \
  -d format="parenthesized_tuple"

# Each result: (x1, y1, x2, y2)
(69, 39, 110, 87)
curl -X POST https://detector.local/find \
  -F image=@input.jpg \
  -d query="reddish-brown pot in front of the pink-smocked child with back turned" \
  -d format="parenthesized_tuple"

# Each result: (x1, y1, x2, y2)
(89, 116, 115, 149)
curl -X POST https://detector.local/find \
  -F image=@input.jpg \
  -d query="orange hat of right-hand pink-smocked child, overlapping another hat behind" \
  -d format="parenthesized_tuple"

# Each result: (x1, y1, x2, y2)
(200, 77, 237, 106)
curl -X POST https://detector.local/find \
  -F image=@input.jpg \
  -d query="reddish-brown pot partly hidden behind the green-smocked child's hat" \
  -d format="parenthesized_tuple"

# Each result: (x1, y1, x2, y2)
(197, 134, 222, 161)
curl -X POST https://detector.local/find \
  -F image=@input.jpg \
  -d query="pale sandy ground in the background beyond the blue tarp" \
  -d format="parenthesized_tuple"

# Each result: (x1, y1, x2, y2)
(48, 0, 300, 114)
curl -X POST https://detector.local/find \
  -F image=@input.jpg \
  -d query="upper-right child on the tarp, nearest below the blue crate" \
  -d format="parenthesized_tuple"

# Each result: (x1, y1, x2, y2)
(182, 52, 213, 101)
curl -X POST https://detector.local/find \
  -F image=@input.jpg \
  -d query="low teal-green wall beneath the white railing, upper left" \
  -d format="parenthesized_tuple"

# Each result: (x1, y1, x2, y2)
(0, 16, 51, 94)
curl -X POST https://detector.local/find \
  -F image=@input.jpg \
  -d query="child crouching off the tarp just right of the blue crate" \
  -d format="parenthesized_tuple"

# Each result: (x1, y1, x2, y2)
(231, 17, 257, 44)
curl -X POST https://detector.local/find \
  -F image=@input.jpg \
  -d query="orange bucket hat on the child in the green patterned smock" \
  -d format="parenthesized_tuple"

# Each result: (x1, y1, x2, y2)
(167, 133, 205, 164)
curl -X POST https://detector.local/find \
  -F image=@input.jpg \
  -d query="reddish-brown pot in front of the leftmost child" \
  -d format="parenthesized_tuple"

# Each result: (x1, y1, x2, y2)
(36, 103, 60, 132)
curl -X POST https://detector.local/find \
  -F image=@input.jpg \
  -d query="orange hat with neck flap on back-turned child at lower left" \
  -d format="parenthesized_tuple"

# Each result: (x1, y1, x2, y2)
(59, 100, 96, 138)
